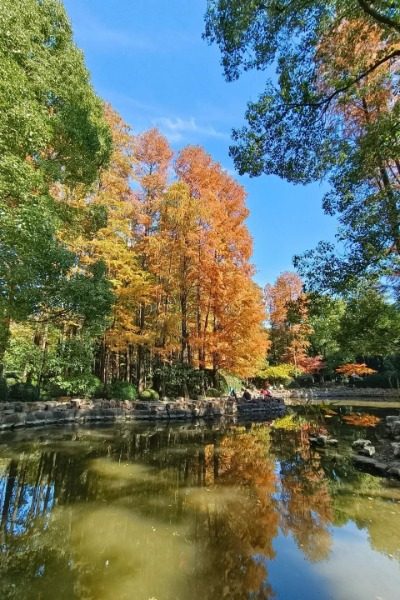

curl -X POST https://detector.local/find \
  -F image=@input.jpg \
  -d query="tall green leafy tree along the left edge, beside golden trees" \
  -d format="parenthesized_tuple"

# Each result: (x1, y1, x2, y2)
(0, 0, 111, 370)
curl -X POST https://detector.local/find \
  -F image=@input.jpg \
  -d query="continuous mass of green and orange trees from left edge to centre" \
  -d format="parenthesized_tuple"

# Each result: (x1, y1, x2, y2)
(0, 0, 267, 404)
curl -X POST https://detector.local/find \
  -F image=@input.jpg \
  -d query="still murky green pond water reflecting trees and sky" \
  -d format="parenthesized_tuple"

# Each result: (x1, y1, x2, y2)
(0, 416, 400, 600)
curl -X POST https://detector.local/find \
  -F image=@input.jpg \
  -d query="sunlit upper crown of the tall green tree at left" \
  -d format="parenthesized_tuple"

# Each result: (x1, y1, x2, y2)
(0, 0, 111, 194)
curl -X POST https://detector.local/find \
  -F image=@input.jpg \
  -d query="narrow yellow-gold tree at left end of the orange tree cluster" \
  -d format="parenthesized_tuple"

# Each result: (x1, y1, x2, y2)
(61, 105, 154, 382)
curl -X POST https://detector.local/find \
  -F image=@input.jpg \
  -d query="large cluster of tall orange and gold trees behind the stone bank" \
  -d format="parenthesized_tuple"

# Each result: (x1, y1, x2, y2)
(64, 107, 267, 386)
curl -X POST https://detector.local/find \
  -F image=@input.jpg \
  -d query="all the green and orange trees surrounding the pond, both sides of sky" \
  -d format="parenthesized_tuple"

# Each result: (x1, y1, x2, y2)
(0, 0, 400, 399)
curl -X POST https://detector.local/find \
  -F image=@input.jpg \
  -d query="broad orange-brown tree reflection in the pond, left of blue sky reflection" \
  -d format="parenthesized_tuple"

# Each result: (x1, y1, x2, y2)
(190, 426, 279, 600)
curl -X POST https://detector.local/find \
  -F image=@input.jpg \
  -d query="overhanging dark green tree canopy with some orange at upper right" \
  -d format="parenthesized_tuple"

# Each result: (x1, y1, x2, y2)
(205, 0, 400, 289)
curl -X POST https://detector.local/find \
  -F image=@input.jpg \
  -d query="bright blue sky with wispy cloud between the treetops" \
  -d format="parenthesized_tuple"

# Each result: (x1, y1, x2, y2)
(64, 0, 335, 285)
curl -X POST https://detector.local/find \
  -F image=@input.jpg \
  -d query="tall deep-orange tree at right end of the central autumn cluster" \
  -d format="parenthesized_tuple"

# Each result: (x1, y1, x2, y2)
(176, 146, 268, 378)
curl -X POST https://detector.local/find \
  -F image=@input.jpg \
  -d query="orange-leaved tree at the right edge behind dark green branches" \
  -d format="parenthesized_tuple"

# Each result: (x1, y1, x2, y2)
(317, 18, 400, 277)
